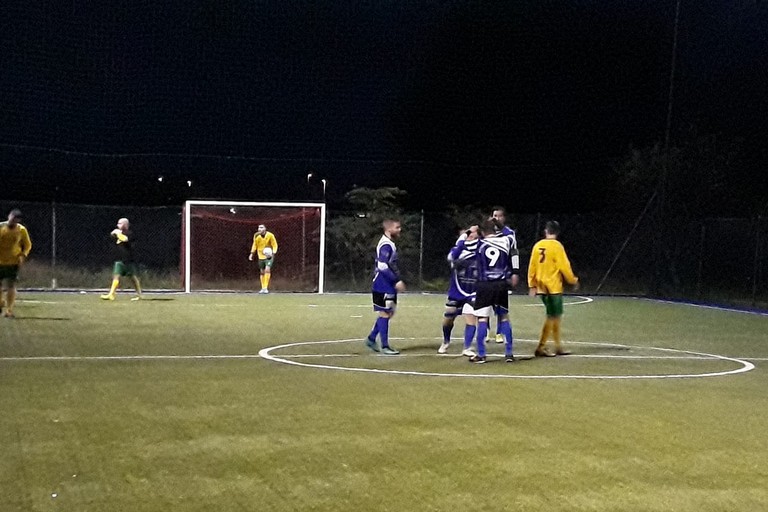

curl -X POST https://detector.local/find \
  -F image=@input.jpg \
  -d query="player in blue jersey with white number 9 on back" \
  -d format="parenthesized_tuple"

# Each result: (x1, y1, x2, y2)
(469, 219, 520, 363)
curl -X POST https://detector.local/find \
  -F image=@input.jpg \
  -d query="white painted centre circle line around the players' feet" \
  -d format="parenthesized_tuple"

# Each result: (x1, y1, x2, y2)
(259, 338, 755, 380)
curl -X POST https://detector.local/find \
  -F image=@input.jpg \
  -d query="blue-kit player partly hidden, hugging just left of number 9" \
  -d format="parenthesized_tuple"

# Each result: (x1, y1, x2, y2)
(437, 226, 478, 357)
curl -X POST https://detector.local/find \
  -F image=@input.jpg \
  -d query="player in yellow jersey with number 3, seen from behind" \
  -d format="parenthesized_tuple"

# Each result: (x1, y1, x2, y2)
(528, 220, 579, 357)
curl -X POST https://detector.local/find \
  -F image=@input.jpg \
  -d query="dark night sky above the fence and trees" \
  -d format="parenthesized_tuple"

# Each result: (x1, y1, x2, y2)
(0, 0, 768, 211)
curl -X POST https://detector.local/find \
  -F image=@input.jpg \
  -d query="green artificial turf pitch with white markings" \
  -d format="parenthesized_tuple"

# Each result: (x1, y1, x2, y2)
(0, 293, 768, 512)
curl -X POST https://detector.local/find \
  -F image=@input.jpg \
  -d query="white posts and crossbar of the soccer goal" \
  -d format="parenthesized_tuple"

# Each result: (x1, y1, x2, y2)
(183, 199, 326, 294)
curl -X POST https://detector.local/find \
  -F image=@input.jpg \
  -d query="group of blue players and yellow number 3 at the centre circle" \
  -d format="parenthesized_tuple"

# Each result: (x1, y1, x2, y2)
(365, 207, 578, 364)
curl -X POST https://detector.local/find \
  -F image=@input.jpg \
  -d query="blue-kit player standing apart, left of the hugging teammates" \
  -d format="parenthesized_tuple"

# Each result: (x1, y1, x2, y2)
(365, 219, 405, 356)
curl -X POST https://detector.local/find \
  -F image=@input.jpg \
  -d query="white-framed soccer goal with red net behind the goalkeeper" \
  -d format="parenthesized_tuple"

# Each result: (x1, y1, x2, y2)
(181, 201, 325, 293)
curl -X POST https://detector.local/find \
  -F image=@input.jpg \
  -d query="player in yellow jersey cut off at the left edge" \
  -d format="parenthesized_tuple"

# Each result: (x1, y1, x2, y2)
(0, 210, 32, 318)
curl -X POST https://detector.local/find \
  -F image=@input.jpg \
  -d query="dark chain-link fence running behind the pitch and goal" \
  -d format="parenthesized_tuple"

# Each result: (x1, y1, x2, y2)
(0, 201, 768, 307)
